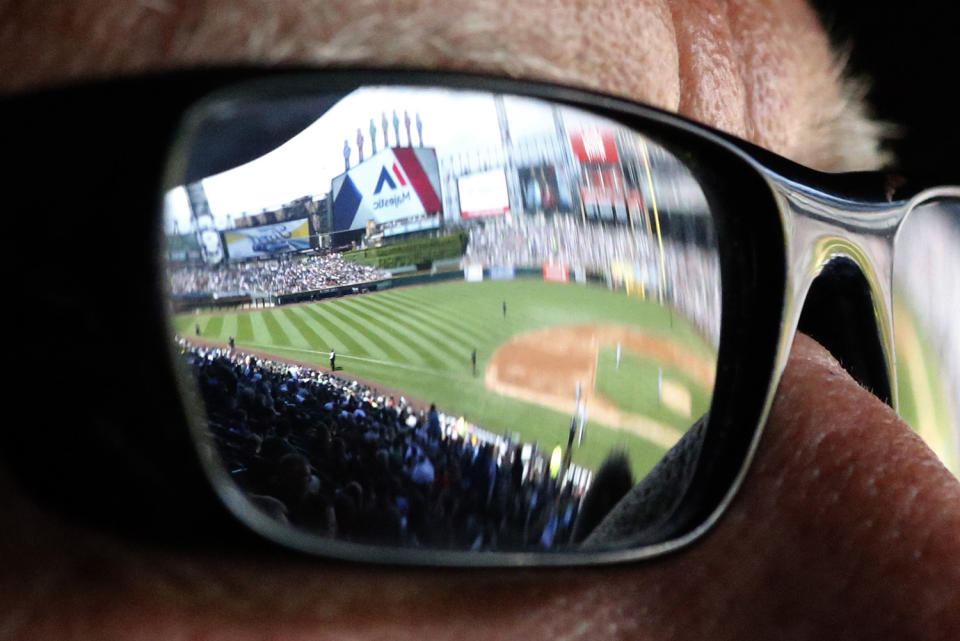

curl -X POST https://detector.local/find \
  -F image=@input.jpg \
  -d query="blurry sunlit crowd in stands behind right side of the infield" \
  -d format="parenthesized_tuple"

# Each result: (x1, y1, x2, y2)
(463, 214, 720, 345)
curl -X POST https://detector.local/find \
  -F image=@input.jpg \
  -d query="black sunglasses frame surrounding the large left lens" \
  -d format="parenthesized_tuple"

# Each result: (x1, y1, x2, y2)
(0, 68, 940, 566)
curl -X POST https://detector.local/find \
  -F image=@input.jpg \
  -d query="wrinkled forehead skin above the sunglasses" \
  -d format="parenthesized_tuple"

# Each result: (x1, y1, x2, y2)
(0, 0, 868, 165)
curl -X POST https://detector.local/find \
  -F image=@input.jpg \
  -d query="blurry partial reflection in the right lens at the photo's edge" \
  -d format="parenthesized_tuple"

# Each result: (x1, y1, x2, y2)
(893, 199, 960, 475)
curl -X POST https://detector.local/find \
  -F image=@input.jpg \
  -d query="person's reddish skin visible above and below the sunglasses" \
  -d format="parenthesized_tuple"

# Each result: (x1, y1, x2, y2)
(0, 0, 960, 640)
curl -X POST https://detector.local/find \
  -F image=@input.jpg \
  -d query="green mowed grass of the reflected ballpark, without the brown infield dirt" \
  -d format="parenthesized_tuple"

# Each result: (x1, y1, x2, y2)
(175, 279, 715, 476)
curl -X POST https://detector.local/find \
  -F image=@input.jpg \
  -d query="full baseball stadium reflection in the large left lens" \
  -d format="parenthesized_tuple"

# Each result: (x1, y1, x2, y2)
(164, 87, 720, 551)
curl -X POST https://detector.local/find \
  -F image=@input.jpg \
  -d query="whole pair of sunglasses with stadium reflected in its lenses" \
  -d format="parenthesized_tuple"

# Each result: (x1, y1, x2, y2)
(3, 69, 960, 566)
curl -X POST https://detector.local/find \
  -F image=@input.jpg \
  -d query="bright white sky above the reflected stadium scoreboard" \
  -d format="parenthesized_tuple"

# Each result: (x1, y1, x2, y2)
(164, 87, 610, 233)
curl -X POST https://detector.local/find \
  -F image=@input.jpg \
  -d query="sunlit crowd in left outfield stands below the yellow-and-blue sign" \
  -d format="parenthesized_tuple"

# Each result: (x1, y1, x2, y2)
(168, 252, 389, 296)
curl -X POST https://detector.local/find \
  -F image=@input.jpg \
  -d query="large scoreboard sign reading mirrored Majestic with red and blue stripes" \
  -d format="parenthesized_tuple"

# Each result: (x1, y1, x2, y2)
(331, 147, 443, 231)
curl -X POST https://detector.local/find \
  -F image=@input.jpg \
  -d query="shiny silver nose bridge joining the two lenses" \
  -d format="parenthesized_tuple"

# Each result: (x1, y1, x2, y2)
(774, 180, 908, 407)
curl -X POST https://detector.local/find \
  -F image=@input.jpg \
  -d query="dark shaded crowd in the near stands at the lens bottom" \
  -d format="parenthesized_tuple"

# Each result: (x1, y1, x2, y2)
(180, 339, 585, 550)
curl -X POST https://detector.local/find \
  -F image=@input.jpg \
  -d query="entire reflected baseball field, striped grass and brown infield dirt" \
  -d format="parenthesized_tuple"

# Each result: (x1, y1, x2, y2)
(174, 279, 716, 477)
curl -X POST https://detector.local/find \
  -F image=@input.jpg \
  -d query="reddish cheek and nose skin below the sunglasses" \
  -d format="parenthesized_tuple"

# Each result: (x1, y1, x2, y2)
(0, 336, 960, 640)
